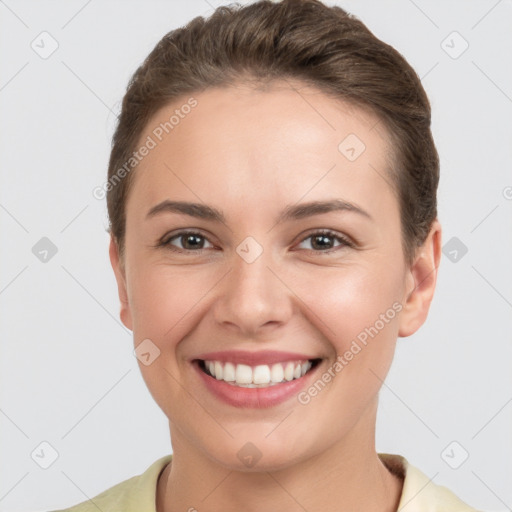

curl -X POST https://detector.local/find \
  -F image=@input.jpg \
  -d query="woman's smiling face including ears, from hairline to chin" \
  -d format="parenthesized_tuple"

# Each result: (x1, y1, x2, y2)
(110, 83, 440, 470)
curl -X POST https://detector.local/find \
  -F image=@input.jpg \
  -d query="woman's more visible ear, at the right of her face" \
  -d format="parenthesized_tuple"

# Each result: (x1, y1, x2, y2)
(398, 219, 442, 337)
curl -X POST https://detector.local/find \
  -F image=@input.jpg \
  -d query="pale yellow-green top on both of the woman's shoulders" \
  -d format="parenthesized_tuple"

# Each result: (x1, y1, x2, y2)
(53, 453, 479, 512)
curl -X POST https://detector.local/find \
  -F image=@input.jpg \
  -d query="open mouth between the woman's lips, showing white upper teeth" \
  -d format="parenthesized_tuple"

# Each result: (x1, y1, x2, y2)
(196, 359, 321, 388)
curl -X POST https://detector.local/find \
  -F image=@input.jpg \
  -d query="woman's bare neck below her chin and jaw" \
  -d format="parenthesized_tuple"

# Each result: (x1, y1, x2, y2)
(157, 403, 402, 512)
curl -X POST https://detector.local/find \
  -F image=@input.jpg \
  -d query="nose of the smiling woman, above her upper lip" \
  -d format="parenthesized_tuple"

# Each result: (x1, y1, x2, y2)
(214, 246, 293, 339)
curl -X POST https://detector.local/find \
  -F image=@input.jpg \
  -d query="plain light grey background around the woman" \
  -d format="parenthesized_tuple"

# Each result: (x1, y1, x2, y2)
(0, 0, 512, 512)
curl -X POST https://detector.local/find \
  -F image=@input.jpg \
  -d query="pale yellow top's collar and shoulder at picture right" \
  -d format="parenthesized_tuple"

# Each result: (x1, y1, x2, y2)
(379, 453, 480, 512)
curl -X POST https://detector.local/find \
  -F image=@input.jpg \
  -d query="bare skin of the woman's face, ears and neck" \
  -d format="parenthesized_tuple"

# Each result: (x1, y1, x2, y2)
(110, 81, 441, 512)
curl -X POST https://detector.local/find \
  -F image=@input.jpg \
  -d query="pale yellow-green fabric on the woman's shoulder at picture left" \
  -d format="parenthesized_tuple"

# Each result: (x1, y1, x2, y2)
(48, 455, 172, 512)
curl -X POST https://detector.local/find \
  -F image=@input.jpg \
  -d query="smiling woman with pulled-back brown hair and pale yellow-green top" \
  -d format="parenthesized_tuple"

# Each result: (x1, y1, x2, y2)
(55, 0, 475, 512)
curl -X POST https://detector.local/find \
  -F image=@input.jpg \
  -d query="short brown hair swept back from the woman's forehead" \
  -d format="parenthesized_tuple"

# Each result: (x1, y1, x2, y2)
(107, 0, 439, 263)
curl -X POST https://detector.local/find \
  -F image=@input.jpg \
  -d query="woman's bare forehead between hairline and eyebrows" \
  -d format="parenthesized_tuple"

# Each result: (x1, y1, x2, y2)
(126, 81, 392, 220)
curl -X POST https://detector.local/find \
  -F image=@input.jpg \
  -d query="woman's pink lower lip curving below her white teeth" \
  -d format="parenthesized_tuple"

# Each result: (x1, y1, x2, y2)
(193, 361, 318, 409)
